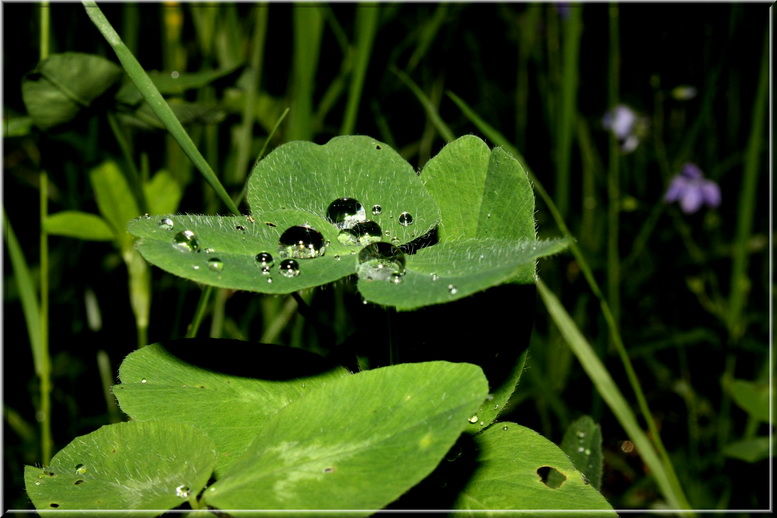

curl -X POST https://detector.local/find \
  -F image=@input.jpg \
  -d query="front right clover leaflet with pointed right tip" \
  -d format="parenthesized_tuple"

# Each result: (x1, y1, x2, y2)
(359, 239, 569, 310)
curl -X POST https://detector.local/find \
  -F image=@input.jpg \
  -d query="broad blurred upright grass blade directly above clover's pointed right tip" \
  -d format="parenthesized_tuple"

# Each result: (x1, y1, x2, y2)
(555, 7, 583, 221)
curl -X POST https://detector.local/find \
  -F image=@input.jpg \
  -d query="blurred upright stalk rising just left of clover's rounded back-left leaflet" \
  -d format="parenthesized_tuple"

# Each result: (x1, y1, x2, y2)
(230, 4, 268, 188)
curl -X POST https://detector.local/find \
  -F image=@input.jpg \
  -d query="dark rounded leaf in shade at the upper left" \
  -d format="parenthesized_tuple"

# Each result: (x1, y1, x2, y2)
(22, 52, 123, 129)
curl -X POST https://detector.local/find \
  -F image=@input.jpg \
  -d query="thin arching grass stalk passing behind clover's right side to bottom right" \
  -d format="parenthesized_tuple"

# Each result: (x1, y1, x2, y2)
(448, 92, 692, 512)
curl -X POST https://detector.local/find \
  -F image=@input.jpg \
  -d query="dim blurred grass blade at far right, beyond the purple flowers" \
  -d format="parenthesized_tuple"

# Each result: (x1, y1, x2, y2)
(727, 38, 770, 342)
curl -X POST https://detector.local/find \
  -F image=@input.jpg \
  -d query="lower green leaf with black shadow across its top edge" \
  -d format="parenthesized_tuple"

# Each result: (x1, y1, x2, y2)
(113, 339, 348, 473)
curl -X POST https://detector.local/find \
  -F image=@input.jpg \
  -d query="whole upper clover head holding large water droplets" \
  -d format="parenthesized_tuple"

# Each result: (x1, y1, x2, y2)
(128, 136, 566, 309)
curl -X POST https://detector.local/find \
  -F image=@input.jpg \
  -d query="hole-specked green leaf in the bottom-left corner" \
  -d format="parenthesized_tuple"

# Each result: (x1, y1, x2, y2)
(24, 421, 216, 516)
